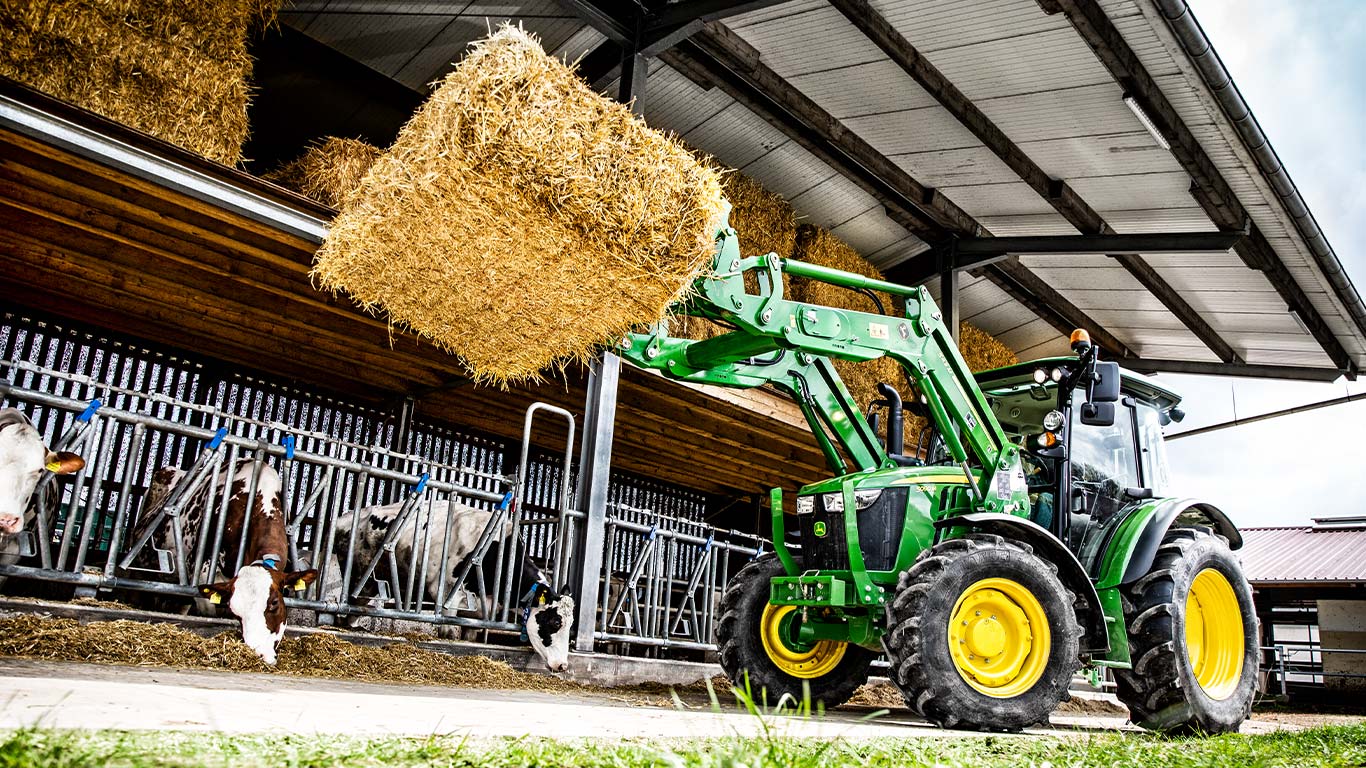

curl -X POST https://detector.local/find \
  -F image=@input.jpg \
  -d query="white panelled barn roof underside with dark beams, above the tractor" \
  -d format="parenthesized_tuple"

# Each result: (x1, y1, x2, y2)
(269, 0, 1366, 379)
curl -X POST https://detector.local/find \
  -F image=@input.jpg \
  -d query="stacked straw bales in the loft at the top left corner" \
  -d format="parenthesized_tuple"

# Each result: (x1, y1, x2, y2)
(0, 0, 277, 165)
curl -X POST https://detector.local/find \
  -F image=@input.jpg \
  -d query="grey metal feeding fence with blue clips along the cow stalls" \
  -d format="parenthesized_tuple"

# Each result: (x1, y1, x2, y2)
(0, 314, 762, 650)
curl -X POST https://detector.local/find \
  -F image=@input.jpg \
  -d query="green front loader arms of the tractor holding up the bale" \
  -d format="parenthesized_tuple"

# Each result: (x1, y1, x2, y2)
(619, 221, 1027, 514)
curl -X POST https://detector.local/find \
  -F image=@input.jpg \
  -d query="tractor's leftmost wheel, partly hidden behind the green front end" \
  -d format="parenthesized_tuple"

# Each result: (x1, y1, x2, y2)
(716, 553, 877, 709)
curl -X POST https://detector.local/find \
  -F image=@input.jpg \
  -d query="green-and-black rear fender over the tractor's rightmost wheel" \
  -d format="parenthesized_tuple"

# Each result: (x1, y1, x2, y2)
(1097, 499, 1243, 589)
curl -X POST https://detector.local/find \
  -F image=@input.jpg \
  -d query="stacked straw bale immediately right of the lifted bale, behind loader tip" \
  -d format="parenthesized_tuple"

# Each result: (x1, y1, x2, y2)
(671, 172, 796, 340)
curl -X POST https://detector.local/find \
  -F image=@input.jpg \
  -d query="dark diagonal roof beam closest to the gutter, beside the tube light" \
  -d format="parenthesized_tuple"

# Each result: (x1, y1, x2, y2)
(1041, 0, 1356, 376)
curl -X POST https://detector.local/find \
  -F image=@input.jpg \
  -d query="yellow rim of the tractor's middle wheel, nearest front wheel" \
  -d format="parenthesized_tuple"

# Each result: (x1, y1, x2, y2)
(948, 578, 1053, 698)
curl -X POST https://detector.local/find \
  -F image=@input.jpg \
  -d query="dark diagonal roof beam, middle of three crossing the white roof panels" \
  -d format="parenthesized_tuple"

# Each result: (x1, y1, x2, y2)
(831, 0, 1242, 362)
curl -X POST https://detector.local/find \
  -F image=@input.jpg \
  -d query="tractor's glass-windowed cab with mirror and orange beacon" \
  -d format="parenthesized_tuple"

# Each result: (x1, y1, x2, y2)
(977, 347, 1184, 563)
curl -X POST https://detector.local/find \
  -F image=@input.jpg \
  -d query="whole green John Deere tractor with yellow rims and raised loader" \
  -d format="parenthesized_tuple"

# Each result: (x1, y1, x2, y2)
(620, 213, 1258, 734)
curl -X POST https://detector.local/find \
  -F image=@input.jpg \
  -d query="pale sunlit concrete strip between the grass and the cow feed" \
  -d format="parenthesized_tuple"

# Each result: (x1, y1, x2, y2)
(0, 659, 1274, 739)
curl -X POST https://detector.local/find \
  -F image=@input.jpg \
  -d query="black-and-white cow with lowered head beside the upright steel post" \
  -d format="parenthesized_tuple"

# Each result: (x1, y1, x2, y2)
(333, 500, 574, 671)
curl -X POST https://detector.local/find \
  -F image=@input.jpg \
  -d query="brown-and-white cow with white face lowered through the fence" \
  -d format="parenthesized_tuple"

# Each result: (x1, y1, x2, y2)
(131, 459, 318, 666)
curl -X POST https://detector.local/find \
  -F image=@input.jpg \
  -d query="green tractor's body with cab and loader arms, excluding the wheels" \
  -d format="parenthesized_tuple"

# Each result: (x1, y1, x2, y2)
(617, 213, 1236, 667)
